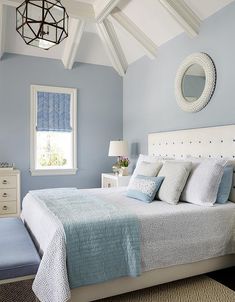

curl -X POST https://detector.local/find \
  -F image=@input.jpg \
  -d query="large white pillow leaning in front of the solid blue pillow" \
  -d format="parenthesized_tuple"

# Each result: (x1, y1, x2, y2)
(180, 159, 227, 206)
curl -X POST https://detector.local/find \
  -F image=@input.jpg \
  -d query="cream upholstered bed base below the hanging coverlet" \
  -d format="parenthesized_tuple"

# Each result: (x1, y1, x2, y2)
(70, 254, 235, 302)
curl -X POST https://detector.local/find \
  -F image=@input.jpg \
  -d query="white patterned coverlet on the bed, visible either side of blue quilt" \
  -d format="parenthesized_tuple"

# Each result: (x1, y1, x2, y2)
(22, 188, 235, 302)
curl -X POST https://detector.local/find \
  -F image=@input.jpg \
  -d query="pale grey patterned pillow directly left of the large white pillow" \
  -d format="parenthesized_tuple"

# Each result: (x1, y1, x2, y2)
(157, 161, 192, 204)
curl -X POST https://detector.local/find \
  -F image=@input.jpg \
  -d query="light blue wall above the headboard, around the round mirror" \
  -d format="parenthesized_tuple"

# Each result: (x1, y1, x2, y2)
(123, 2, 235, 172)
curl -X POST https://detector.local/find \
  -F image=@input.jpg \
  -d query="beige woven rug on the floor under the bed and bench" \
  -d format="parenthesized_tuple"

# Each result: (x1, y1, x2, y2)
(0, 276, 235, 302)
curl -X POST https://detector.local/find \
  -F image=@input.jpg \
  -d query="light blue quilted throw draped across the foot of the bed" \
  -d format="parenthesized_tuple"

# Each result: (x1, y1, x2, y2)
(31, 188, 141, 288)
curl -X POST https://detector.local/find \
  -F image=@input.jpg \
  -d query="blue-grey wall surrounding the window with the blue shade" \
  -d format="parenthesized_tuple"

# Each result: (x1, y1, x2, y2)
(0, 54, 123, 197)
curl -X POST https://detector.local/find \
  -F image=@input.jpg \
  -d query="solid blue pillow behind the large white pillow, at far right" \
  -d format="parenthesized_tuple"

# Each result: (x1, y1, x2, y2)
(216, 166, 233, 203)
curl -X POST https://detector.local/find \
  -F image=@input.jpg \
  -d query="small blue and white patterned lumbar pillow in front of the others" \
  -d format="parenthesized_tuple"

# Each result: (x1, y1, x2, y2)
(127, 175, 164, 203)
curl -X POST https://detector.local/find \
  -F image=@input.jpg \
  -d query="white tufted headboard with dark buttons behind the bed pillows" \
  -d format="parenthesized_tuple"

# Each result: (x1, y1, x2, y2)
(148, 125, 235, 202)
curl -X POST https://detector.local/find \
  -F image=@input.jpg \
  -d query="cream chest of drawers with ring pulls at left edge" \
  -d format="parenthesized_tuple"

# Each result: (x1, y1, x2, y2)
(0, 169, 20, 217)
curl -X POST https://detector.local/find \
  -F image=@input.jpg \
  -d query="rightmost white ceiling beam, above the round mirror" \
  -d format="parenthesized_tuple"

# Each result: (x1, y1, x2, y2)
(159, 0, 201, 38)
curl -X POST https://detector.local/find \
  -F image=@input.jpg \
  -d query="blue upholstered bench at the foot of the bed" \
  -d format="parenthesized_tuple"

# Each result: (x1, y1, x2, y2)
(0, 218, 40, 284)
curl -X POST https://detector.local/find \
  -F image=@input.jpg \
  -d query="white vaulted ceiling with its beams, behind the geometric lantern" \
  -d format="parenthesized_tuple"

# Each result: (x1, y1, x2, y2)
(0, 0, 233, 75)
